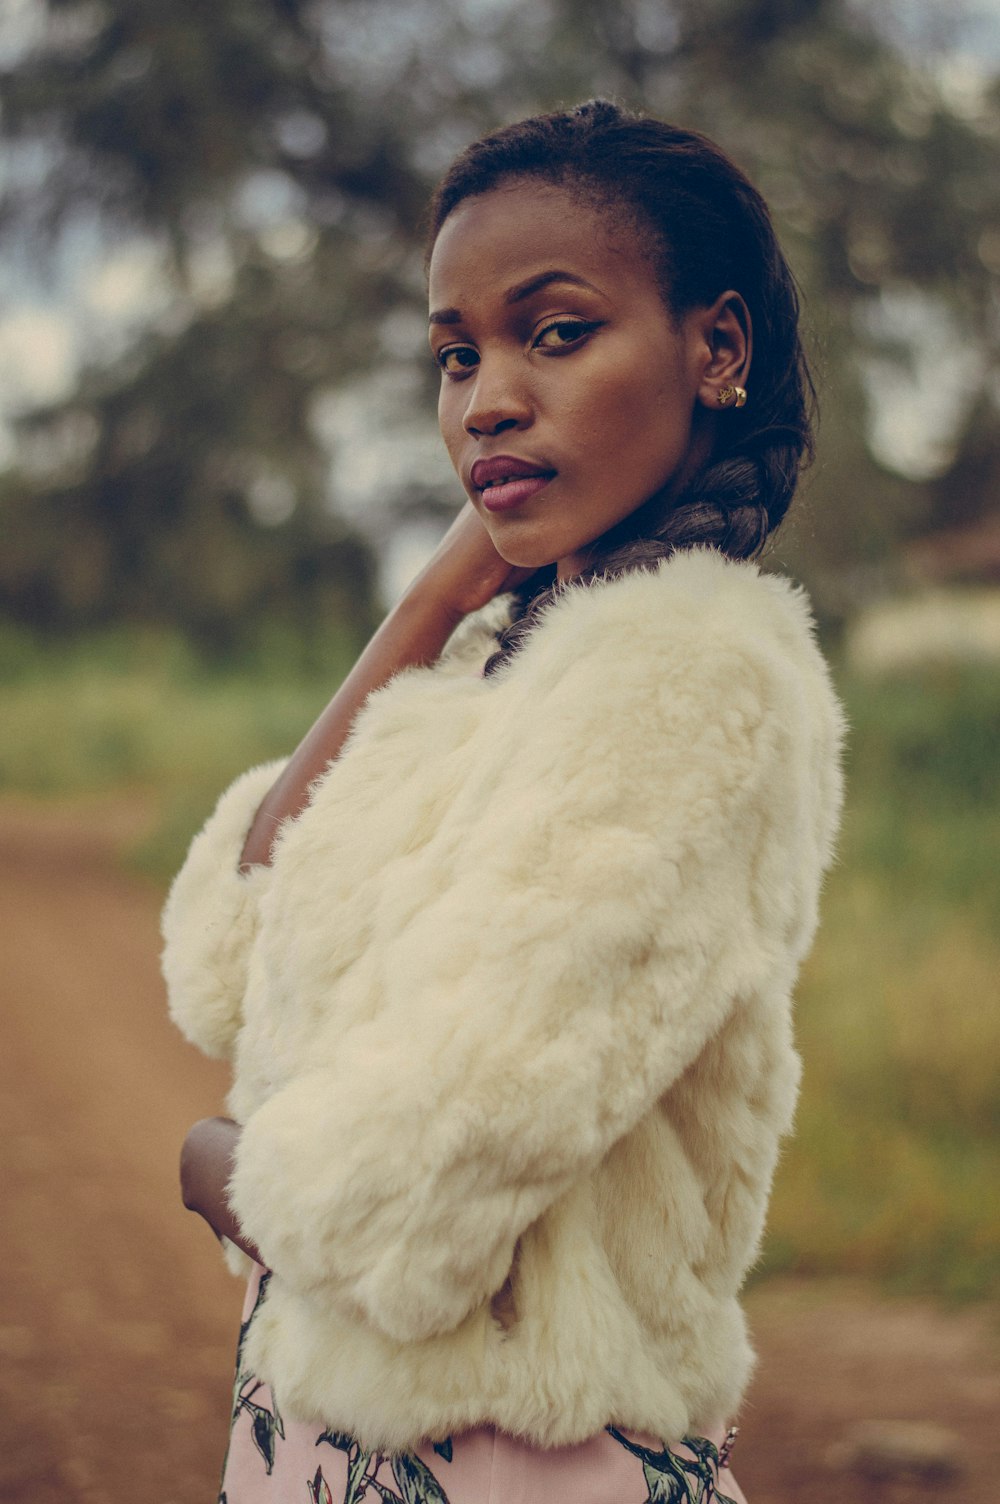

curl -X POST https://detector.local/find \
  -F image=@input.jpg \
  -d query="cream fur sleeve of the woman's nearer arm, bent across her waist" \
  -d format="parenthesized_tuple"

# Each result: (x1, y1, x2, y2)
(201, 552, 841, 1342)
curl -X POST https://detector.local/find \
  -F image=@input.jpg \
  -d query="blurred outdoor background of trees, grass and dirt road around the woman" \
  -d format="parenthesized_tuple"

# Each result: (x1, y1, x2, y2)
(0, 0, 1000, 1504)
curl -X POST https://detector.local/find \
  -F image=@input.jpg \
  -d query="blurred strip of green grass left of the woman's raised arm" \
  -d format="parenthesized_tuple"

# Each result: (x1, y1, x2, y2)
(0, 629, 347, 880)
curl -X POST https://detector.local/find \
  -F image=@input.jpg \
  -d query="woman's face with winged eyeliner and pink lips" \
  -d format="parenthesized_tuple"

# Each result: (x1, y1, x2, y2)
(430, 180, 734, 578)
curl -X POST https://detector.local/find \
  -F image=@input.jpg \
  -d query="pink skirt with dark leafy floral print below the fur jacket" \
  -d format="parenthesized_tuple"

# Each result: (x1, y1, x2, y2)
(220, 1268, 746, 1504)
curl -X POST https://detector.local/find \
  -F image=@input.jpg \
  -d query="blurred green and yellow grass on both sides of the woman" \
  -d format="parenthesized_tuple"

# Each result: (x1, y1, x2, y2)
(0, 632, 1000, 1298)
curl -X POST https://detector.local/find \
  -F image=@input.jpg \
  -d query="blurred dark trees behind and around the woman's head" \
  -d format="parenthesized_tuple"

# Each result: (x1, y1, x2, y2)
(0, 0, 1000, 641)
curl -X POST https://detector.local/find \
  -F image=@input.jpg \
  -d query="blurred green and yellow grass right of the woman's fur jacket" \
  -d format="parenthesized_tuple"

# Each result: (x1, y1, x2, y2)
(764, 669, 1000, 1296)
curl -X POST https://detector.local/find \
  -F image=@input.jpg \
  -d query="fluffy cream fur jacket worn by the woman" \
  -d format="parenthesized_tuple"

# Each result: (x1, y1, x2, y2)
(165, 550, 842, 1450)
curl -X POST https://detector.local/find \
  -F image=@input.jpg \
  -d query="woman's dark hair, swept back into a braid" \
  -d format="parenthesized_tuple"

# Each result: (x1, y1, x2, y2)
(427, 99, 815, 672)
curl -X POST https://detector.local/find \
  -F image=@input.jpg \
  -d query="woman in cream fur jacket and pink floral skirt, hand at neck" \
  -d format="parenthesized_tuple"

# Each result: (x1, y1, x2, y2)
(164, 101, 841, 1504)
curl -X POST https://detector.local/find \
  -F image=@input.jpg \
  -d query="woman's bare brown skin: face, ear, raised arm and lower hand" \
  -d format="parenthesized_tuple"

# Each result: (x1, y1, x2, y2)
(180, 182, 750, 1262)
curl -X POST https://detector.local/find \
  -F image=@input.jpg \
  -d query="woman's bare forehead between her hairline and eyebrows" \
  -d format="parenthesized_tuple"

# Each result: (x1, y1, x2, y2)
(429, 182, 659, 311)
